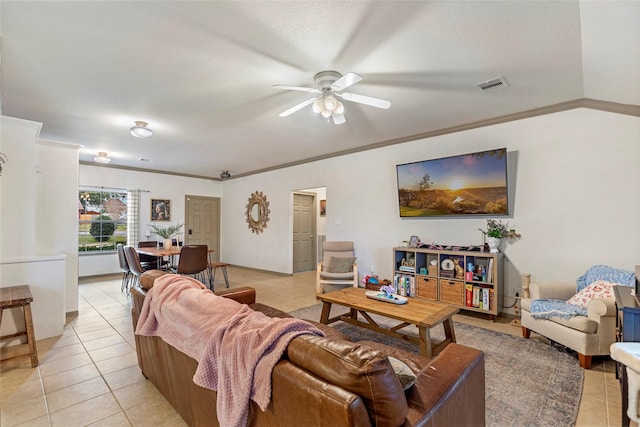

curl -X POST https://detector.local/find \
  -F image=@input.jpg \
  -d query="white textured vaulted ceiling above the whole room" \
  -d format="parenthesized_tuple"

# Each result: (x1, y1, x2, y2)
(0, 1, 640, 179)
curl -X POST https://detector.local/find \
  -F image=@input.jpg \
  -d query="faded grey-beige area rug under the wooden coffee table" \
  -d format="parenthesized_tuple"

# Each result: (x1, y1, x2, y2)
(290, 304, 584, 427)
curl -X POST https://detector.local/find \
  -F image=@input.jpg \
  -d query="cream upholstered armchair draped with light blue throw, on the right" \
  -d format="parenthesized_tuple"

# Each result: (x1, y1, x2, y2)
(521, 282, 616, 369)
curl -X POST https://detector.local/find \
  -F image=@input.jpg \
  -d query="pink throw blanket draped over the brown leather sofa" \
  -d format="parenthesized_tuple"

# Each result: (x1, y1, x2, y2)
(136, 274, 324, 426)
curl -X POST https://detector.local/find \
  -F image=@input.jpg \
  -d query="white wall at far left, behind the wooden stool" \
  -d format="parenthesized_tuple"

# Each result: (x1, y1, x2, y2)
(0, 116, 79, 345)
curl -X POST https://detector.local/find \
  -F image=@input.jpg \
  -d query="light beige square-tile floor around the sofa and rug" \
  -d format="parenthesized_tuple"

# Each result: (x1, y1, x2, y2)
(0, 267, 621, 427)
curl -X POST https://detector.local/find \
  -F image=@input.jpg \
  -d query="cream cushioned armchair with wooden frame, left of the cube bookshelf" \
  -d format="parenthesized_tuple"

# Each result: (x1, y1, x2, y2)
(316, 241, 358, 295)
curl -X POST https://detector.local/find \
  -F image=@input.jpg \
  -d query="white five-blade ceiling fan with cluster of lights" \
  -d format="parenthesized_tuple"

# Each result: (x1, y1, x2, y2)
(271, 71, 391, 125)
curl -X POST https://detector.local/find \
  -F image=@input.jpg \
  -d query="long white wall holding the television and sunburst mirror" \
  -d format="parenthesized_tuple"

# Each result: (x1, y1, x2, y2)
(221, 109, 640, 312)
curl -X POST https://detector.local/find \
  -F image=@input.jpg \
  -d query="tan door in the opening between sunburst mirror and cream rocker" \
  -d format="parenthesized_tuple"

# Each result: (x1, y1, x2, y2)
(293, 193, 316, 273)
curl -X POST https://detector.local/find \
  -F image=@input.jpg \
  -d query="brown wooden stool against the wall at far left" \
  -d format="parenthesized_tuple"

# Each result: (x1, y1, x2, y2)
(0, 285, 38, 368)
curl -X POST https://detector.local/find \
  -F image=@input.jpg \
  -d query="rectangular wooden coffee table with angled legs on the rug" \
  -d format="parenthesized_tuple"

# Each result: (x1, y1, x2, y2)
(318, 288, 459, 358)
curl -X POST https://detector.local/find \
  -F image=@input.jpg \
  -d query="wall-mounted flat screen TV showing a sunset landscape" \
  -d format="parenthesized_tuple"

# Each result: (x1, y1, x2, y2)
(396, 148, 509, 217)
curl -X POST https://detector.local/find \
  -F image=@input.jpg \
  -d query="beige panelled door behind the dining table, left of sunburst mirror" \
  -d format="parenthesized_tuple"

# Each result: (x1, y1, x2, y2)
(184, 195, 220, 261)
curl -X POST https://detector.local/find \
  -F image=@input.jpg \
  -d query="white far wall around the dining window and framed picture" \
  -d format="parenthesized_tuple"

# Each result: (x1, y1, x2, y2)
(76, 165, 224, 277)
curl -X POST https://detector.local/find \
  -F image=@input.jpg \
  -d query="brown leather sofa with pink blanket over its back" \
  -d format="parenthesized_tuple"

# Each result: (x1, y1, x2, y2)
(131, 271, 485, 427)
